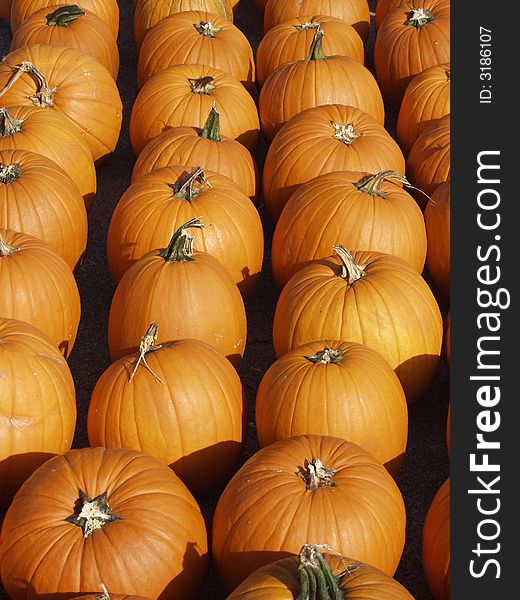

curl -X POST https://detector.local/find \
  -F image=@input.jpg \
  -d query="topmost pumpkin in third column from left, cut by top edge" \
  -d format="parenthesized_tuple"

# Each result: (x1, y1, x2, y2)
(264, 0, 370, 42)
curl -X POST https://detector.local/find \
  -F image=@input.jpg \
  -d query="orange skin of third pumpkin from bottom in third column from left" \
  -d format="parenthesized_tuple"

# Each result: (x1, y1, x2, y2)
(256, 340, 408, 476)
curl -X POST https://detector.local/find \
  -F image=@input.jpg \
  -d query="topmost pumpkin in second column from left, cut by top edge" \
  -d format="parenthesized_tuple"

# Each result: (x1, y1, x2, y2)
(134, 0, 233, 49)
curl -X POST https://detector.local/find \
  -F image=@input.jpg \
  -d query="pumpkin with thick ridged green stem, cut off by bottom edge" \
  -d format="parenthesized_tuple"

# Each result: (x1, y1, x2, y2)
(227, 544, 413, 600)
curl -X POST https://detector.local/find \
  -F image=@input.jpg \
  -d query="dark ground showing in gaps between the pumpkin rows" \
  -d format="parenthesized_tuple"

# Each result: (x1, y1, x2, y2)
(0, 0, 449, 600)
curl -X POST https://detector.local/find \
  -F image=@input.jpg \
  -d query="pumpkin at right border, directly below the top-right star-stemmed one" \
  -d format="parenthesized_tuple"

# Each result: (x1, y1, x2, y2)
(396, 63, 451, 154)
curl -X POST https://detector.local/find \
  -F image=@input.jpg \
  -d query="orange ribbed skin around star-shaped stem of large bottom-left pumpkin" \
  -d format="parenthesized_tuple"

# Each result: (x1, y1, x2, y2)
(0, 448, 207, 600)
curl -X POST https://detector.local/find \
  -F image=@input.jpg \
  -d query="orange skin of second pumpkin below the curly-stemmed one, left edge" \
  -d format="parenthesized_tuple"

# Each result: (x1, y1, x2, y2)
(0, 150, 88, 269)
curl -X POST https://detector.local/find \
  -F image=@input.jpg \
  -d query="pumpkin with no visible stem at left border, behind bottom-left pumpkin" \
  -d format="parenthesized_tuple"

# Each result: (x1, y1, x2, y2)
(0, 317, 76, 506)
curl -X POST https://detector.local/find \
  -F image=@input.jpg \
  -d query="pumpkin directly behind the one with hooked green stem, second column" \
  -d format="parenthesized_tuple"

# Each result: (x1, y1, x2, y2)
(107, 166, 264, 296)
